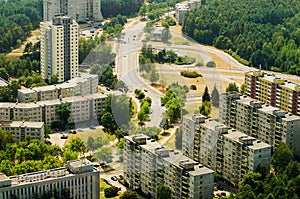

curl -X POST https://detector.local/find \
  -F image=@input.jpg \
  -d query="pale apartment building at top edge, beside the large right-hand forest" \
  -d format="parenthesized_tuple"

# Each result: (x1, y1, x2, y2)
(175, 0, 201, 24)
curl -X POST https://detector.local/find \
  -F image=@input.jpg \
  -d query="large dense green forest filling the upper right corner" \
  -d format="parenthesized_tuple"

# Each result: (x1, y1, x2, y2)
(182, 0, 300, 75)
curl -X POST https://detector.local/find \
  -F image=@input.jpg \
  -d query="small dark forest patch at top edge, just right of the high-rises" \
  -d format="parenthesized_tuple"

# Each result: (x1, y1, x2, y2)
(101, 0, 144, 18)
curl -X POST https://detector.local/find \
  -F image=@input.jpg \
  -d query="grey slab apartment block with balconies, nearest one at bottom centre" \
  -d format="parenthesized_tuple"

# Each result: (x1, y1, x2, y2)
(124, 134, 214, 199)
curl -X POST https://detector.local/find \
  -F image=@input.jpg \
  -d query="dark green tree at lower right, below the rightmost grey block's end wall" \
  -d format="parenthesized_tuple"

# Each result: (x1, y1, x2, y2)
(271, 143, 294, 172)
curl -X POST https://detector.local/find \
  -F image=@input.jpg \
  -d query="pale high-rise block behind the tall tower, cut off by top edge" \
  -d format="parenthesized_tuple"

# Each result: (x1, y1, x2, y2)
(43, 0, 103, 22)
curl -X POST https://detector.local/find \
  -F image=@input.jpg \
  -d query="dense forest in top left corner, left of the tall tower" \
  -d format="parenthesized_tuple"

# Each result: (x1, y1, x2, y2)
(0, 0, 43, 53)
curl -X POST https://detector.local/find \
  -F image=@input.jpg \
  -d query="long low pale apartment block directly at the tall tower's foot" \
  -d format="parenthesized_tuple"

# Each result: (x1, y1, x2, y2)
(18, 74, 98, 102)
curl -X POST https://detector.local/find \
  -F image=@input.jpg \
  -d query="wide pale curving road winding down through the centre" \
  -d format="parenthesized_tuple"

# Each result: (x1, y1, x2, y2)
(116, 21, 165, 126)
